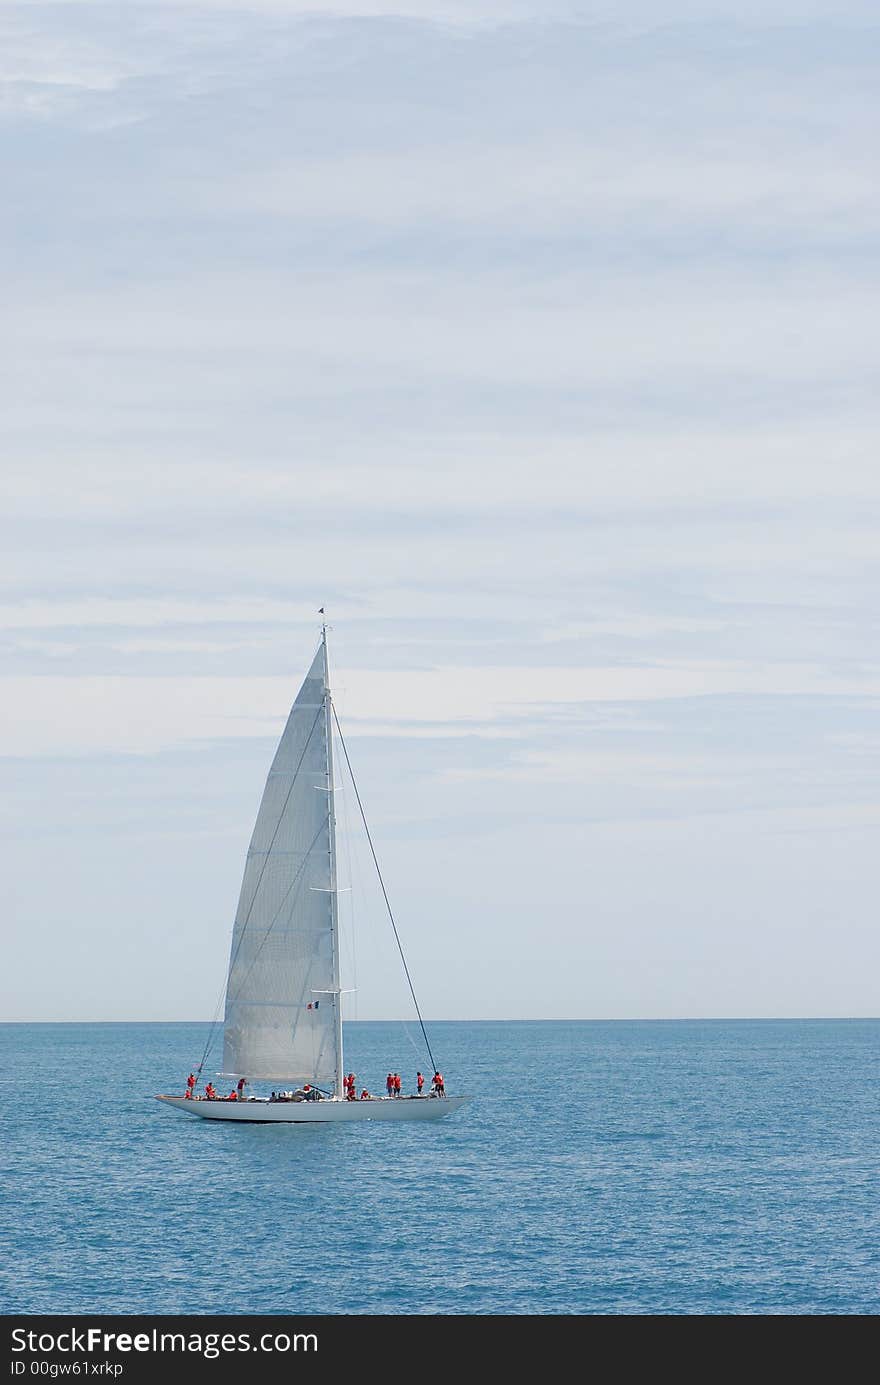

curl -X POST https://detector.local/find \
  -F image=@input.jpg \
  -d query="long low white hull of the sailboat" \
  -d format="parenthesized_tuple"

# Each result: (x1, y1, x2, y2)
(157, 1096, 470, 1125)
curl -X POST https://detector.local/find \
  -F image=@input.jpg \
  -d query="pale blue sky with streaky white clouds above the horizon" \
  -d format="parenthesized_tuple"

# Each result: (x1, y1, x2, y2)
(0, 0, 880, 1019)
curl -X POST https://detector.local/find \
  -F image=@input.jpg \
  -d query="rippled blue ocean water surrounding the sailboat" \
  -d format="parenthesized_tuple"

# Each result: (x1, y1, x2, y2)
(0, 1019, 880, 1314)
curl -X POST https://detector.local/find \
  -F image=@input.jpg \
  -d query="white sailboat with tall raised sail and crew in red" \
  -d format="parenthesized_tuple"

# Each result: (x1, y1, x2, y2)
(157, 623, 470, 1125)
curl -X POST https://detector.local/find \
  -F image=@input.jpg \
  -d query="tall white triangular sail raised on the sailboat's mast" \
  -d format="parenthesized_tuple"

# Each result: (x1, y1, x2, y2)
(223, 643, 341, 1086)
